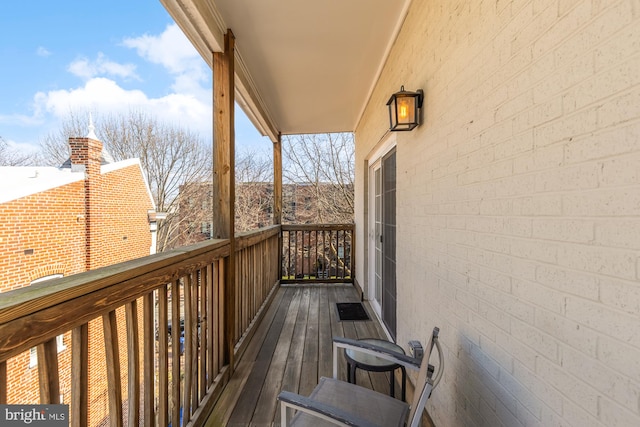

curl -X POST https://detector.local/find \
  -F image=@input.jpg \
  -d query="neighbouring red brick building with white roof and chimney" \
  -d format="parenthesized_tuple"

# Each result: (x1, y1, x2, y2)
(0, 138, 155, 424)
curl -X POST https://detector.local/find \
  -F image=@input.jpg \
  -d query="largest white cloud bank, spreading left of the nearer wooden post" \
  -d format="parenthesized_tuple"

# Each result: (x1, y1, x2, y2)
(10, 24, 212, 147)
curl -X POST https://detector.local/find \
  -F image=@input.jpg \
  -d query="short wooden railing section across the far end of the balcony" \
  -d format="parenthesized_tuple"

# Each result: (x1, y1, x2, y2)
(280, 224, 355, 283)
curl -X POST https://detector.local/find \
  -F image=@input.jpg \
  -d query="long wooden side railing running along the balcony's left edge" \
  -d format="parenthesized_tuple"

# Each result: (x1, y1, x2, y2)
(0, 226, 280, 426)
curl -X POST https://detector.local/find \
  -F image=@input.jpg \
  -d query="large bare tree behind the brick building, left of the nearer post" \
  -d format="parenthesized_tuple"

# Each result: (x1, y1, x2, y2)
(41, 111, 211, 251)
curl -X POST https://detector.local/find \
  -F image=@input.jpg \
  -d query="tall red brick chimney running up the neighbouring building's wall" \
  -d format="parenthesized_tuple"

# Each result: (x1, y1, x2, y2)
(69, 135, 102, 271)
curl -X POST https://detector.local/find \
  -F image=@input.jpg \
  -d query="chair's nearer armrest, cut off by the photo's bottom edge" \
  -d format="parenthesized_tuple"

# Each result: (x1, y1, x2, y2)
(278, 391, 377, 427)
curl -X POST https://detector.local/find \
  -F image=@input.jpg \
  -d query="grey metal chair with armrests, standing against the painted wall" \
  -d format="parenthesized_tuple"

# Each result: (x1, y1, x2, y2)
(278, 327, 444, 427)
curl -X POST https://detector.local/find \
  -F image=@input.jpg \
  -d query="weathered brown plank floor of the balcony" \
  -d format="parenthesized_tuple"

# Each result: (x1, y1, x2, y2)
(206, 284, 392, 427)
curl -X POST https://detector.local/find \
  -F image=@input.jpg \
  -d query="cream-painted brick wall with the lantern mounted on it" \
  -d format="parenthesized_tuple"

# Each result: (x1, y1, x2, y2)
(356, 0, 640, 426)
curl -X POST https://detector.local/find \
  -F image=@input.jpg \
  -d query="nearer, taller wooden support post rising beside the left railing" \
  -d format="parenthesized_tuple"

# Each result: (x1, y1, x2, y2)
(213, 30, 236, 371)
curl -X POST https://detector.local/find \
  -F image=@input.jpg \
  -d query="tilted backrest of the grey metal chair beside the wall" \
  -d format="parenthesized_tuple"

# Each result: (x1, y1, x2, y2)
(407, 327, 444, 427)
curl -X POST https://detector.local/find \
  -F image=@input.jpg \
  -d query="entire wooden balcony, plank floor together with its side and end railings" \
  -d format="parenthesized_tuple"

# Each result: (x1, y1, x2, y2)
(0, 225, 396, 427)
